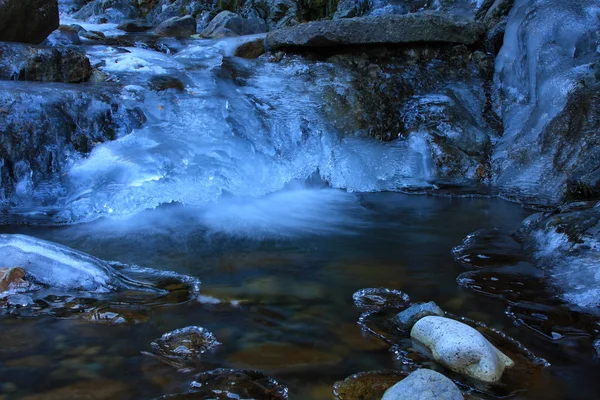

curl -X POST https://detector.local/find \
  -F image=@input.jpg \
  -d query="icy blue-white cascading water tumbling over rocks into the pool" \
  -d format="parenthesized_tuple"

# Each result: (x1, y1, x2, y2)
(5, 24, 432, 223)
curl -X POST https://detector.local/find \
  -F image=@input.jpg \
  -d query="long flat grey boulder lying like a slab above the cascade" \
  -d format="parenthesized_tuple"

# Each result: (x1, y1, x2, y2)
(267, 13, 484, 50)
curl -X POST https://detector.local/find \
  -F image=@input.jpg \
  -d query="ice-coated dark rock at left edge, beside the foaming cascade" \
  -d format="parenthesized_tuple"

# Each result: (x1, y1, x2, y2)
(0, 81, 145, 209)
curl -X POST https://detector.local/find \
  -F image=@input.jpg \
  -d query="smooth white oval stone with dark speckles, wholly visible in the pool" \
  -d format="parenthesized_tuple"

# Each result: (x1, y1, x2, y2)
(410, 316, 514, 382)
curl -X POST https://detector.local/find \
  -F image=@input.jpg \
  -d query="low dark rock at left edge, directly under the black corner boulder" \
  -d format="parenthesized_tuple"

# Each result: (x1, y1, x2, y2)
(0, 43, 92, 83)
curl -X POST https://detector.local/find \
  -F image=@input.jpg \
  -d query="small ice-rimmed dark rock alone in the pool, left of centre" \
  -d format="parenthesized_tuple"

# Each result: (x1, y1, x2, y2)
(147, 326, 221, 368)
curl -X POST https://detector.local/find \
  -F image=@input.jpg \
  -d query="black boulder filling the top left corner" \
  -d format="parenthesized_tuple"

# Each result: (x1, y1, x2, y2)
(0, 0, 59, 44)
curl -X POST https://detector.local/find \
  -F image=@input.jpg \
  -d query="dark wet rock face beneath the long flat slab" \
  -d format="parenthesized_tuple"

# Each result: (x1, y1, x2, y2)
(323, 45, 501, 183)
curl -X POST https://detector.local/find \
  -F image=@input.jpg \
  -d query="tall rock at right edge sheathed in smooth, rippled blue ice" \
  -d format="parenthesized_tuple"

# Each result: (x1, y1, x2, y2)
(492, 0, 600, 204)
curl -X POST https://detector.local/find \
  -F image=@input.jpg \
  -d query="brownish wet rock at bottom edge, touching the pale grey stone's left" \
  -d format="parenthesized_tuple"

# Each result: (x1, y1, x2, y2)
(333, 370, 406, 400)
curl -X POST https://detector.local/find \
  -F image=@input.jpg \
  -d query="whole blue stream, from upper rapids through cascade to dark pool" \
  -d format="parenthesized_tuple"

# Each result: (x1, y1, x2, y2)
(0, 1, 600, 400)
